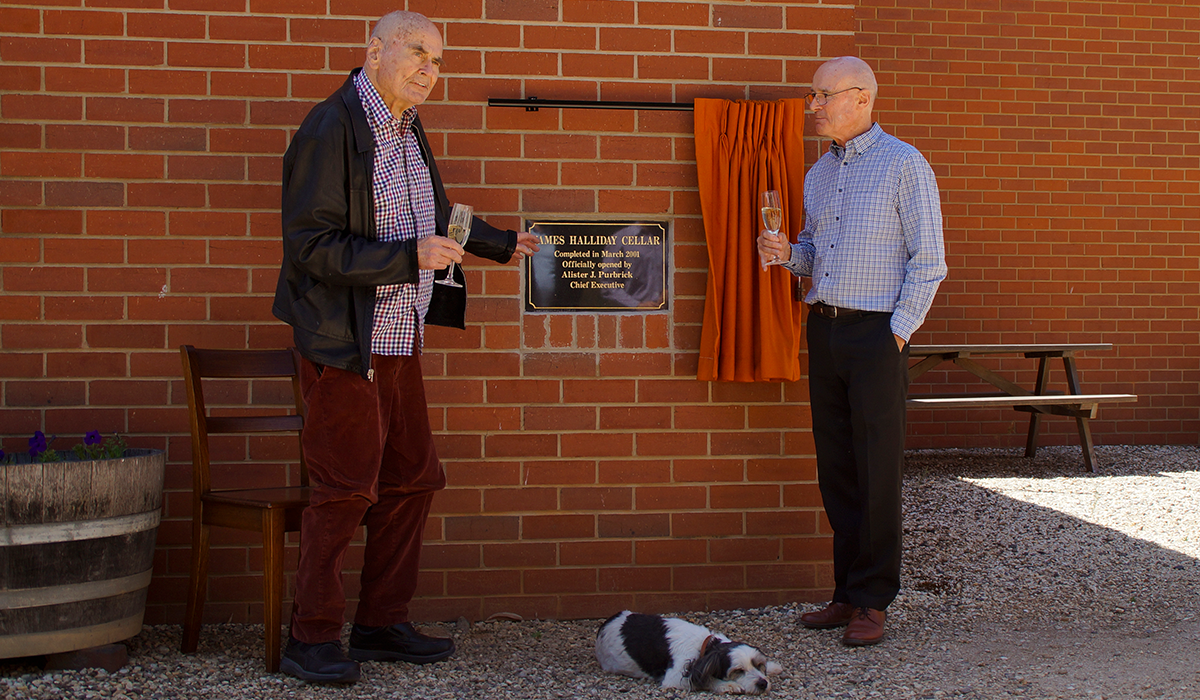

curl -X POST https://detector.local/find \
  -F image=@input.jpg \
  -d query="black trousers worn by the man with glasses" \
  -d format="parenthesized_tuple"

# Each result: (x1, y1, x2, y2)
(806, 312, 908, 610)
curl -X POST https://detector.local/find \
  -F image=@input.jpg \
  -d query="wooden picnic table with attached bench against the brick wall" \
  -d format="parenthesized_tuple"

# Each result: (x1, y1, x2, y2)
(908, 342, 1138, 472)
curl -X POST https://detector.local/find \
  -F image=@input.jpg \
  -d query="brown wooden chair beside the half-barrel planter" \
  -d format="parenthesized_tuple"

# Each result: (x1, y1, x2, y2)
(179, 346, 308, 672)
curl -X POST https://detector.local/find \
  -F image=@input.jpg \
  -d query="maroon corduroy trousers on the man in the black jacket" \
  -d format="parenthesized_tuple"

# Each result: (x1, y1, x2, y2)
(292, 355, 445, 644)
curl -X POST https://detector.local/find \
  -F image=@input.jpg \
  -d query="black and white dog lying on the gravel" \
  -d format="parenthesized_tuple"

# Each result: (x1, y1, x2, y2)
(596, 610, 784, 695)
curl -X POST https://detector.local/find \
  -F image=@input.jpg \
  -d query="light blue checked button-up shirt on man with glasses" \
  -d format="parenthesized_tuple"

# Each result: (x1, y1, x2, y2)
(785, 124, 946, 342)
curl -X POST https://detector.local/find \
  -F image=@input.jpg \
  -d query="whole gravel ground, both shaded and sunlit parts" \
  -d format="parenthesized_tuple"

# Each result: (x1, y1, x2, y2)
(0, 447, 1200, 700)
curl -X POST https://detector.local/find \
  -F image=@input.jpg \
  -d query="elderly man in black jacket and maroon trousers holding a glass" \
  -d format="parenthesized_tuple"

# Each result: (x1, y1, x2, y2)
(272, 12, 538, 683)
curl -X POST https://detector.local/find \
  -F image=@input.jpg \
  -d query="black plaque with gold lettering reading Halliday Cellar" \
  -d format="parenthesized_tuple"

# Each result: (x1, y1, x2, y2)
(526, 221, 667, 311)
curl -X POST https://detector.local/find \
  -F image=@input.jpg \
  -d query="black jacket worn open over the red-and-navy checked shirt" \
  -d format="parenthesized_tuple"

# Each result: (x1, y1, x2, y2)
(271, 68, 517, 379)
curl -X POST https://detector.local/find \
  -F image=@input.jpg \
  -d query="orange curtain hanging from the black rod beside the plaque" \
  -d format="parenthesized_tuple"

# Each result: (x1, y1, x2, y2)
(694, 100, 804, 382)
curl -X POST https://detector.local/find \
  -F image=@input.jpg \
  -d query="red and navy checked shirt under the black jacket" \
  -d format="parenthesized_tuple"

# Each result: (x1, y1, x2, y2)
(354, 72, 437, 355)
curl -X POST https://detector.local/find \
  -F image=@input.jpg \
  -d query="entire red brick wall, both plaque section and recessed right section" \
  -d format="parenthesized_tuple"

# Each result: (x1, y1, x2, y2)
(0, 0, 1200, 622)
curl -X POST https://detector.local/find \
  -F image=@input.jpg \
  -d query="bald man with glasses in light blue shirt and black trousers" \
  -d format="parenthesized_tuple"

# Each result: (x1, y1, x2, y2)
(758, 56, 946, 646)
